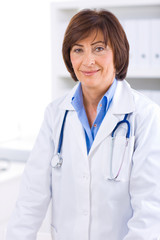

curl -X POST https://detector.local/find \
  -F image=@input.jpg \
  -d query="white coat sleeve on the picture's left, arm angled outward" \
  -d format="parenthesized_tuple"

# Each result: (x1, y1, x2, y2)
(6, 107, 54, 240)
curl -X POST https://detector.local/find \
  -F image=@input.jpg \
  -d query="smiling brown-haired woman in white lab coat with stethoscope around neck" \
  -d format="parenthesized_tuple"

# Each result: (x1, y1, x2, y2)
(7, 10, 160, 240)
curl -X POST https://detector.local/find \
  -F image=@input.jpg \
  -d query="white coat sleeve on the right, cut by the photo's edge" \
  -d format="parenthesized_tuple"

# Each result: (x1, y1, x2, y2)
(123, 104, 160, 240)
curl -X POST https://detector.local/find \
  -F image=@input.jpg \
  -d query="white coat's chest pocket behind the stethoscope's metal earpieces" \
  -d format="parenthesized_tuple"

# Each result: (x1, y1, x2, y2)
(106, 136, 134, 181)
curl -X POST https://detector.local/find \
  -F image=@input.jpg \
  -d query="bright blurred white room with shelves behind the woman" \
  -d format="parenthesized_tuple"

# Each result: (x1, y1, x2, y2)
(0, 0, 160, 240)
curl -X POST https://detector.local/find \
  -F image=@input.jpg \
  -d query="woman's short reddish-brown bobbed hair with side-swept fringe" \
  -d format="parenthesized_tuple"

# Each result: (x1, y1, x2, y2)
(62, 9, 129, 81)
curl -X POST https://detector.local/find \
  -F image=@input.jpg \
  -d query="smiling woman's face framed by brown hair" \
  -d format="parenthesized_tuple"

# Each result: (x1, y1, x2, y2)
(70, 31, 115, 91)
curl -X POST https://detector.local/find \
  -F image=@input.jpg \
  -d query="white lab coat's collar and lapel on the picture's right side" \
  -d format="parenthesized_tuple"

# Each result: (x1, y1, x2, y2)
(89, 81, 135, 154)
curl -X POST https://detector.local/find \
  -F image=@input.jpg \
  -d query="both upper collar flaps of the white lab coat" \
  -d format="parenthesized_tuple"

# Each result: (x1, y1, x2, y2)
(59, 80, 135, 114)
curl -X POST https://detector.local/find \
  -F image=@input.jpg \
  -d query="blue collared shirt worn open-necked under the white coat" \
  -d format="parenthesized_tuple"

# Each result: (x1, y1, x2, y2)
(71, 79, 117, 153)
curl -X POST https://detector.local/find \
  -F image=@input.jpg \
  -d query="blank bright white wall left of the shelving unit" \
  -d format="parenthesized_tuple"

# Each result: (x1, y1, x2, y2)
(0, 0, 51, 140)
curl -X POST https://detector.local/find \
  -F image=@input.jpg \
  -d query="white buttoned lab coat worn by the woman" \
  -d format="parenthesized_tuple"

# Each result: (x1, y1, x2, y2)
(7, 81, 160, 240)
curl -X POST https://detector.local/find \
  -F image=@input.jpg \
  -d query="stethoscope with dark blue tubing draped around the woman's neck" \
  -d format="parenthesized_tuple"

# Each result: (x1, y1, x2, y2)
(52, 110, 130, 181)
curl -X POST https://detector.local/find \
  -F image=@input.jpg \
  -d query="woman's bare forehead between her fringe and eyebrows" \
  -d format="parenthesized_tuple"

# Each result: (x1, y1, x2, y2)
(75, 30, 105, 44)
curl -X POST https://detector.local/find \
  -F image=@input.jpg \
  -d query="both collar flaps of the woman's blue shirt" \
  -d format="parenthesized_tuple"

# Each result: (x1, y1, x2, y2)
(71, 78, 117, 112)
